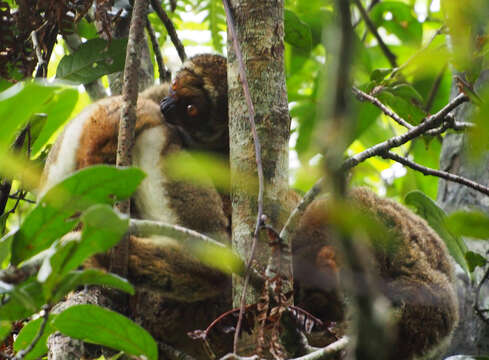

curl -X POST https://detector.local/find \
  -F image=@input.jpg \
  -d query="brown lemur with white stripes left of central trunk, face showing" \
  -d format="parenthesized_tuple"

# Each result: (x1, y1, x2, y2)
(41, 55, 229, 302)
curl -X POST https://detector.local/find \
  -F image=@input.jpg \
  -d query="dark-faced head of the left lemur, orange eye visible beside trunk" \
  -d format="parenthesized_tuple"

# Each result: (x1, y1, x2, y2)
(160, 54, 229, 153)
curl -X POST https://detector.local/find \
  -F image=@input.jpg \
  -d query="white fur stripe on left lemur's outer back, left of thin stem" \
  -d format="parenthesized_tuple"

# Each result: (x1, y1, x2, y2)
(39, 104, 98, 197)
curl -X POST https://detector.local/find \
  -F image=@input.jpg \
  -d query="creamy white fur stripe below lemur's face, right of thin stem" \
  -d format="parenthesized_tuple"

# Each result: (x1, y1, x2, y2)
(132, 126, 178, 224)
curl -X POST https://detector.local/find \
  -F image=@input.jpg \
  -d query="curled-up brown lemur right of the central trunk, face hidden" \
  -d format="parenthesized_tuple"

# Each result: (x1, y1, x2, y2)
(293, 188, 458, 360)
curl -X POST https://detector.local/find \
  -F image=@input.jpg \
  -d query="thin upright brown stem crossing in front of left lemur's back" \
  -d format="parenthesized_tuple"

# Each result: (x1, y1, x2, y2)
(110, 0, 148, 276)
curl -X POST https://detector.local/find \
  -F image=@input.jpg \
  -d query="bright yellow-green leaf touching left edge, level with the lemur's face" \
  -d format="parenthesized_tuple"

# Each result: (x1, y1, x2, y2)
(0, 81, 60, 146)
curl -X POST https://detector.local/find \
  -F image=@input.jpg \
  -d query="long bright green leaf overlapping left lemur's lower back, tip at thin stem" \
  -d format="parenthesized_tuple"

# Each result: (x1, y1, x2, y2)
(10, 165, 144, 265)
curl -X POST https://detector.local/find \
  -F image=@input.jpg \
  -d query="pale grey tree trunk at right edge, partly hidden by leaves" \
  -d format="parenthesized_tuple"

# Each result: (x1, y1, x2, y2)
(437, 70, 489, 355)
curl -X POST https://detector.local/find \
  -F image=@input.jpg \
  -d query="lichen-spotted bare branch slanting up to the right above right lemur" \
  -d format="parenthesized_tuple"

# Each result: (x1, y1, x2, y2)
(343, 94, 469, 170)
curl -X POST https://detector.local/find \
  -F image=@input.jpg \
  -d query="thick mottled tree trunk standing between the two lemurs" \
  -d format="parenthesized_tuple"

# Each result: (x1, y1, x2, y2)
(228, 0, 290, 350)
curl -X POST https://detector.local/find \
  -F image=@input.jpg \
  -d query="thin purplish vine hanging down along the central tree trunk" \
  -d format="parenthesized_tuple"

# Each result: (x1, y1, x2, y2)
(223, 0, 265, 353)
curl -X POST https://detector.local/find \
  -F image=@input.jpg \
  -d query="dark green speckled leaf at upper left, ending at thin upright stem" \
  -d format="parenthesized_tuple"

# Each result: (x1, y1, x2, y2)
(56, 38, 127, 84)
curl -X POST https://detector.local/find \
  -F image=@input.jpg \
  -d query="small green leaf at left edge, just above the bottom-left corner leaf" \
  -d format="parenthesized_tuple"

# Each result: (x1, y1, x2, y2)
(0, 279, 45, 321)
